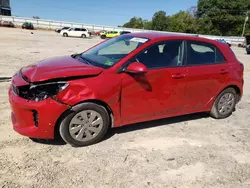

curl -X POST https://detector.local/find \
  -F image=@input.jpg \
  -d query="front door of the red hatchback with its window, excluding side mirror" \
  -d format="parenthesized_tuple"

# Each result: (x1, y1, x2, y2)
(121, 40, 186, 124)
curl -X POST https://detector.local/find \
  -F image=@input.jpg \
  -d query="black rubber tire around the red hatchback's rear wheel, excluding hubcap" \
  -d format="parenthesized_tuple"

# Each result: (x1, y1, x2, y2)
(210, 88, 237, 119)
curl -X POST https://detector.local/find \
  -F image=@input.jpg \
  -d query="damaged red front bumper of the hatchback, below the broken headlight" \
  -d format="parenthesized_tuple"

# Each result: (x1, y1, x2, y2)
(9, 76, 68, 139)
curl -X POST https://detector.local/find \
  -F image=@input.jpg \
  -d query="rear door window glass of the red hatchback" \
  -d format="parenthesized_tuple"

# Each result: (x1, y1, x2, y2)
(187, 41, 225, 65)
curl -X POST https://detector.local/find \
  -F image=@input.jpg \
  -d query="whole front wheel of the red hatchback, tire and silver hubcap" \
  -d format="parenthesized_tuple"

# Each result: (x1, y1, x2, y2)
(59, 103, 110, 147)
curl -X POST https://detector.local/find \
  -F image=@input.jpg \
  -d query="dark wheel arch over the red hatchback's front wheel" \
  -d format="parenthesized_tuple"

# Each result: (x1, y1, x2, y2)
(54, 99, 114, 138)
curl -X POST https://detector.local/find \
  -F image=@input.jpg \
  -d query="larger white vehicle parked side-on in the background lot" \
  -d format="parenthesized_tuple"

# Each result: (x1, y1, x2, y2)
(60, 27, 90, 38)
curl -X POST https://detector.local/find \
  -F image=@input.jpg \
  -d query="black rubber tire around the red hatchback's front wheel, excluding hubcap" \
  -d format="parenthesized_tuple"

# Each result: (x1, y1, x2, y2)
(59, 102, 110, 147)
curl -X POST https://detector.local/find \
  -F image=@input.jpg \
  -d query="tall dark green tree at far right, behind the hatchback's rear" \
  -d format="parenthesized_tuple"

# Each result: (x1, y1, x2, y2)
(197, 0, 250, 35)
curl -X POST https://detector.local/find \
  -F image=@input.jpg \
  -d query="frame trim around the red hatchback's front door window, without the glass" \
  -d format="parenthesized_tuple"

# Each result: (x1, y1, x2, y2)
(120, 39, 187, 73)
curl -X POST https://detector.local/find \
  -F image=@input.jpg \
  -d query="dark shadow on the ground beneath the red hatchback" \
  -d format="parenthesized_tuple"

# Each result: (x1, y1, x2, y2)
(30, 113, 209, 146)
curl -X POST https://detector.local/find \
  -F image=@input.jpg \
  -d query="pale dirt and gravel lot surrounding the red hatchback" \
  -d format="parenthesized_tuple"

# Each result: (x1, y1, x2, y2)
(0, 28, 250, 188)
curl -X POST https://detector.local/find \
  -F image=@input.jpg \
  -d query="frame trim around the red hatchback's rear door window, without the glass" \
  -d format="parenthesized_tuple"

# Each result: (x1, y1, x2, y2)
(183, 40, 227, 67)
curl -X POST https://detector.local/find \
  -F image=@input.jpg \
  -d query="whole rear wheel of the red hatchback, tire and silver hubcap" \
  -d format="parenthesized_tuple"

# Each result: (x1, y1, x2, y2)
(210, 88, 237, 119)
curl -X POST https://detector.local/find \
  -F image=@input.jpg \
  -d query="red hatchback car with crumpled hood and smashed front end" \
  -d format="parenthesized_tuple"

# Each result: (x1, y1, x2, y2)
(9, 33, 244, 146)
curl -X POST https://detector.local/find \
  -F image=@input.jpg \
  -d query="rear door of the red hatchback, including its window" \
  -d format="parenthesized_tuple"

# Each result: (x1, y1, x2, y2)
(185, 40, 229, 111)
